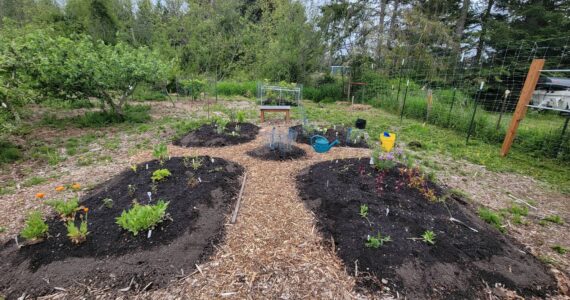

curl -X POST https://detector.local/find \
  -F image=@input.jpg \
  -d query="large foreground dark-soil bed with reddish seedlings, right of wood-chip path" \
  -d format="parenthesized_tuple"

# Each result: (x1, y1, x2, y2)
(297, 158, 557, 299)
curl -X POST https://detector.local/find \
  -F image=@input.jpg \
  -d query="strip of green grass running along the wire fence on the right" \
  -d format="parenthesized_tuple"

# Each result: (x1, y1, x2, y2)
(295, 101, 570, 193)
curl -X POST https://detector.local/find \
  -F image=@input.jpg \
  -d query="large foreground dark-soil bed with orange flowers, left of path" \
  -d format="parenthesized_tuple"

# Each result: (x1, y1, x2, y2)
(0, 157, 244, 299)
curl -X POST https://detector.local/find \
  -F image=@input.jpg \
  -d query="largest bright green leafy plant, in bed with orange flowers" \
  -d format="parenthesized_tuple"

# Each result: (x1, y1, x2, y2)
(117, 200, 168, 235)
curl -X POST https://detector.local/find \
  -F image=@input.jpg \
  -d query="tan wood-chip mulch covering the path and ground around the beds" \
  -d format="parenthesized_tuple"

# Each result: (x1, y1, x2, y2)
(0, 101, 570, 299)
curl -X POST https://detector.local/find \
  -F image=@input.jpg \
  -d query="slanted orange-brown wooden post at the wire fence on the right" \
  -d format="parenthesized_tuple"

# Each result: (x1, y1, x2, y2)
(501, 59, 544, 156)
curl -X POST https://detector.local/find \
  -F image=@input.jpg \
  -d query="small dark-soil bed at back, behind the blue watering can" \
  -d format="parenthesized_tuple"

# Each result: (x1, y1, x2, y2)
(290, 125, 368, 148)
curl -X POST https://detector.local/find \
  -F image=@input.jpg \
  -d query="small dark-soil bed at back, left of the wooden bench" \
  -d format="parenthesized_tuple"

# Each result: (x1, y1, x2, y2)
(173, 123, 259, 147)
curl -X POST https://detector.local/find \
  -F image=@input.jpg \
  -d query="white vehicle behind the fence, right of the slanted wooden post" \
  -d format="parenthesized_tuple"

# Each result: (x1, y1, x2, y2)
(532, 77, 570, 110)
